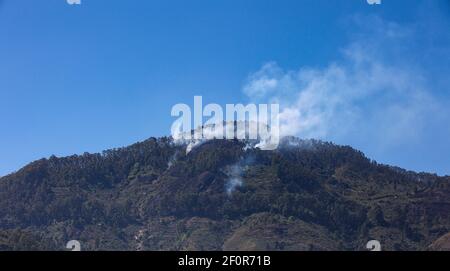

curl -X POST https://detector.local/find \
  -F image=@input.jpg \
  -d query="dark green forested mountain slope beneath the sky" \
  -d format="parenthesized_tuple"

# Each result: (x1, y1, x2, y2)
(0, 138, 450, 250)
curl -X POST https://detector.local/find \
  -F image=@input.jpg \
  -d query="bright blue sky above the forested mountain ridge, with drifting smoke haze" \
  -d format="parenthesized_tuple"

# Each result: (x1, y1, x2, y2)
(0, 0, 450, 176)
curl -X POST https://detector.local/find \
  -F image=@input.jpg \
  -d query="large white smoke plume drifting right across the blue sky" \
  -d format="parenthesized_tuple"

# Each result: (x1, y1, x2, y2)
(243, 15, 449, 151)
